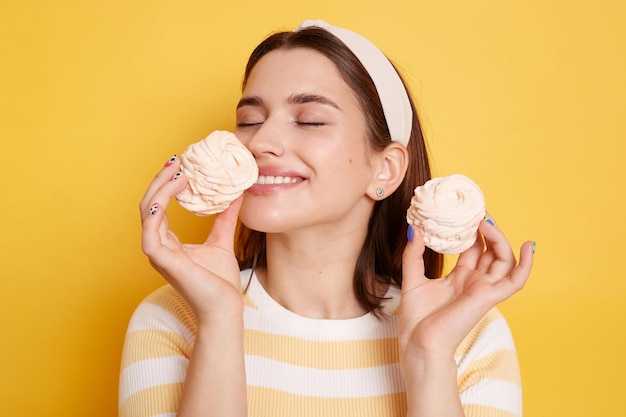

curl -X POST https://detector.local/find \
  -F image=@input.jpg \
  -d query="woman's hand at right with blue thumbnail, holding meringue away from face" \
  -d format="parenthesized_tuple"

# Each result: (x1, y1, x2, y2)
(399, 216, 534, 363)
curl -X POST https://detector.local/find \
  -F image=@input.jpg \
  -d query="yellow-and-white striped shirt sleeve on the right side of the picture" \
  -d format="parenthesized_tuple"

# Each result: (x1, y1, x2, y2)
(455, 309, 522, 417)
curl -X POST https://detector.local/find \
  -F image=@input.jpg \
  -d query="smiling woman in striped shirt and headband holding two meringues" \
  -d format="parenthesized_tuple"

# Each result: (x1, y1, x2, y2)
(120, 22, 533, 417)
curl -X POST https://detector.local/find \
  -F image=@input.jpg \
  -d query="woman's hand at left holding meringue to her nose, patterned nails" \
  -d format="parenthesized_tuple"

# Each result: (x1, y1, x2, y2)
(139, 157, 243, 326)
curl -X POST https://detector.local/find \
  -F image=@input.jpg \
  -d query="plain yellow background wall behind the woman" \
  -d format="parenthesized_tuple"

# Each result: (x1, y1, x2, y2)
(0, 0, 626, 417)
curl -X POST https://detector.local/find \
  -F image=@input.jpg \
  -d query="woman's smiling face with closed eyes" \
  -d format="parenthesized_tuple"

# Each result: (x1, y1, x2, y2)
(235, 48, 375, 233)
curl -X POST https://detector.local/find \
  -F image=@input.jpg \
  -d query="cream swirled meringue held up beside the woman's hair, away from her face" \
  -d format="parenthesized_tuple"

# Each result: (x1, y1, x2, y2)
(406, 174, 485, 255)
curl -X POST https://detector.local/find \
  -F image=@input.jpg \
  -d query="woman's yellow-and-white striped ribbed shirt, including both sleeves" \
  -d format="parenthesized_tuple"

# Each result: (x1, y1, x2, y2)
(119, 270, 521, 417)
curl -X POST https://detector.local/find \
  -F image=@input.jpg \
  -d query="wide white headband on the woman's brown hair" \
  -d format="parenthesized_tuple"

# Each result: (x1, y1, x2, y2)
(298, 20, 413, 146)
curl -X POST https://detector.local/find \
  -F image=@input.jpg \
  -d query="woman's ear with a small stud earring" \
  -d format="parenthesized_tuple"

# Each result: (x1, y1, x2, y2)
(367, 142, 409, 200)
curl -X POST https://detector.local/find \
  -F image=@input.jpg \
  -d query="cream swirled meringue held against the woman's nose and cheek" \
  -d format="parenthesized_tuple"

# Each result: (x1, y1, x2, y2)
(176, 130, 259, 216)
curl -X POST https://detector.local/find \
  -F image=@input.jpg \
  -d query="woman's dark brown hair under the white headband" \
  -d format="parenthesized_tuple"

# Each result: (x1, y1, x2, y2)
(236, 27, 443, 312)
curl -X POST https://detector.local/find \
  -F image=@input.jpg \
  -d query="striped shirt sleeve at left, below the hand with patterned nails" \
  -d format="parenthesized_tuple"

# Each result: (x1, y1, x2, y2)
(119, 286, 197, 417)
